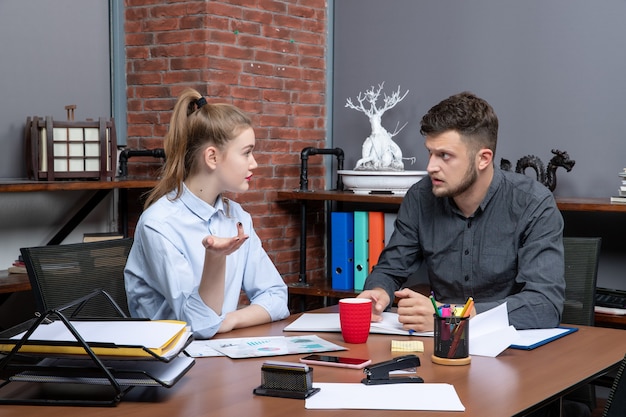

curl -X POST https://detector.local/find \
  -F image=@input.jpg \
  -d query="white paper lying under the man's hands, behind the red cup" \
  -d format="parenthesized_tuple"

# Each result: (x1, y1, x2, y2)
(283, 311, 433, 336)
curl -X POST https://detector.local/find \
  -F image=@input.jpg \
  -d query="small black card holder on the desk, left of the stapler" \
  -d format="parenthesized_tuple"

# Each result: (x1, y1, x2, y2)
(253, 361, 320, 399)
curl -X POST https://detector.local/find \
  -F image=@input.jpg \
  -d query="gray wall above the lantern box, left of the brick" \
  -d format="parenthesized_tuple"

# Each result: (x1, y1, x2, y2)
(0, 0, 111, 178)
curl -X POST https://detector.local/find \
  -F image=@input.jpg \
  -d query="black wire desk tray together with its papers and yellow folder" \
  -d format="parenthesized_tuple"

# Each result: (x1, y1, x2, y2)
(0, 291, 195, 406)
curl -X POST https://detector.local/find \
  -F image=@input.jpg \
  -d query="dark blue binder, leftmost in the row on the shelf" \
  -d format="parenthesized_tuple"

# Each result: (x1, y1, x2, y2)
(330, 211, 354, 290)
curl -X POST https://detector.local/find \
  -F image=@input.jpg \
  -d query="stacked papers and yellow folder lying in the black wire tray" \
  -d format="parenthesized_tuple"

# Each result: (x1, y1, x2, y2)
(0, 319, 195, 394)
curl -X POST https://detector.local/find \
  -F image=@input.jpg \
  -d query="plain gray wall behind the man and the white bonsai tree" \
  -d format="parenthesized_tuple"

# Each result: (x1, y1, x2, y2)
(332, 0, 626, 198)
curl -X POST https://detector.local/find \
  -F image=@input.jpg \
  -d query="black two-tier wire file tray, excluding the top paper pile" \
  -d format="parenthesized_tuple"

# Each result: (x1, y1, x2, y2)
(0, 290, 195, 406)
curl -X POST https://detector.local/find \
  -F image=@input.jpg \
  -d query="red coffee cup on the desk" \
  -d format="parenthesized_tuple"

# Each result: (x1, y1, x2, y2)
(339, 298, 372, 343)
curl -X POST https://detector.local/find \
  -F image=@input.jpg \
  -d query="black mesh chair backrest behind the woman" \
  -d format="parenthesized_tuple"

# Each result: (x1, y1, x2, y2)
(20, 238, 133, 318)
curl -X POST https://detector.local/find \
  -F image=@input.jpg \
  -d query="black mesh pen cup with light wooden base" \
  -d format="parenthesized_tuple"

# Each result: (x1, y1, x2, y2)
(431, 314, 471, 365)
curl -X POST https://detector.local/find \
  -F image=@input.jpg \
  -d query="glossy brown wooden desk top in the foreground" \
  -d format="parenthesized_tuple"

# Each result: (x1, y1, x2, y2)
(0, 307, 626, 417)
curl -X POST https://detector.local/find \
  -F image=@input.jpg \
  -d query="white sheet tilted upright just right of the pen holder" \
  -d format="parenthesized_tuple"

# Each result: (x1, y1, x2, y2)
(470, 303, 519, 358)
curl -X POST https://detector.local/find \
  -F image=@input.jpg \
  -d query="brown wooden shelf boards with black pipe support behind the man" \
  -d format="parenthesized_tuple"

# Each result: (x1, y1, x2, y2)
(277, 190, 626, 326)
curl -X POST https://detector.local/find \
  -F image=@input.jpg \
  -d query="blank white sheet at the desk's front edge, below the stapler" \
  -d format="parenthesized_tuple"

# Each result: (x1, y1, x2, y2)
(304, 382, 465, 411)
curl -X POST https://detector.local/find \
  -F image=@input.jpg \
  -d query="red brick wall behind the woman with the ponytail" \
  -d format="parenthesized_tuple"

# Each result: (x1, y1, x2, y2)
(125, 0, 327, 290)
